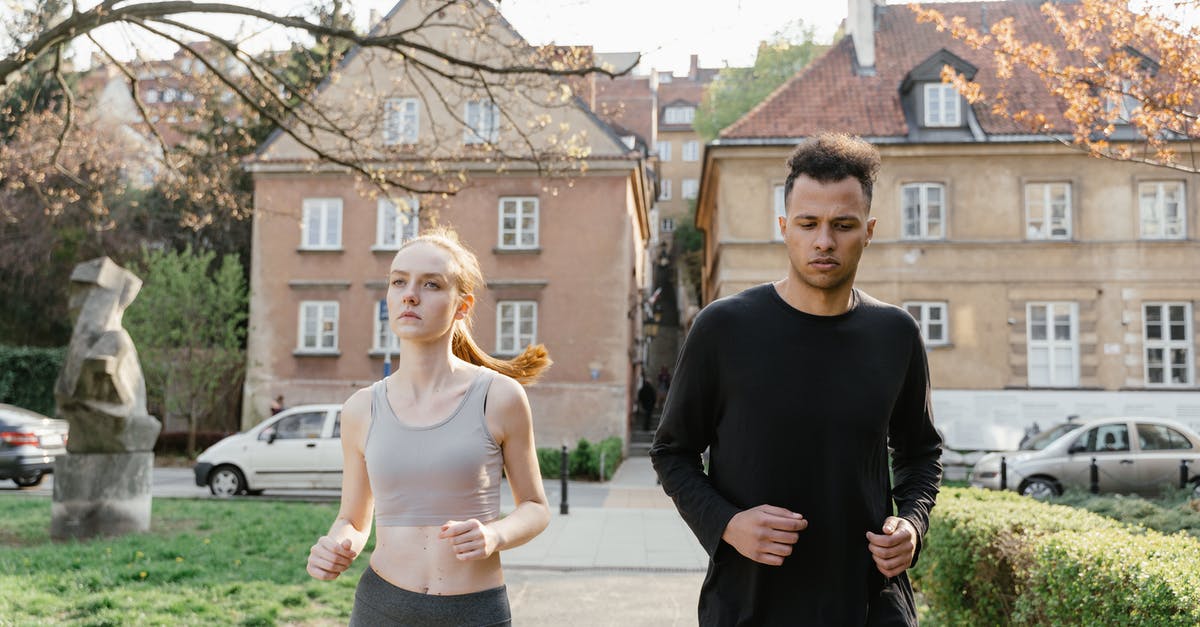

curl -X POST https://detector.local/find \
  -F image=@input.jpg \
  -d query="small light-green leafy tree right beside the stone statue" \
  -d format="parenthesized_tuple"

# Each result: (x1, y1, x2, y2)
(125, 247, 247, 455)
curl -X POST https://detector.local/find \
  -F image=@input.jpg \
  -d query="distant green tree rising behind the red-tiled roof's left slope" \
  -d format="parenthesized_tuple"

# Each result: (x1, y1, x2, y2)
(694, 22, 828, 142)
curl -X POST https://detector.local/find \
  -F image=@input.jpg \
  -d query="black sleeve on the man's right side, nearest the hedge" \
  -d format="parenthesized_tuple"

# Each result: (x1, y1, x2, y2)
(888, 330, 942, 566)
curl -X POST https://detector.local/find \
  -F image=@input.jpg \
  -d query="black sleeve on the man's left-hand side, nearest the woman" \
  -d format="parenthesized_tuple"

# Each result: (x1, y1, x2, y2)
(650, 305, 739, 557)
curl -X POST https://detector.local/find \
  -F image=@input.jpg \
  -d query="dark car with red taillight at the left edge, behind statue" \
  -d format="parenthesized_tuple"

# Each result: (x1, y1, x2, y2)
(0, 404, 67, 488)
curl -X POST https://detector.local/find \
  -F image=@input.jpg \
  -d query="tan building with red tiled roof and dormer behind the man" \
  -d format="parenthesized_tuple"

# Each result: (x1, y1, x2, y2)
(697, 0, 1200, 449)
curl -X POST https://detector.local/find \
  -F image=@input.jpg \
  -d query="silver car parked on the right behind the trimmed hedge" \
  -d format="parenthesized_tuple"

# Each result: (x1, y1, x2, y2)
(971, 417, 1200, 498)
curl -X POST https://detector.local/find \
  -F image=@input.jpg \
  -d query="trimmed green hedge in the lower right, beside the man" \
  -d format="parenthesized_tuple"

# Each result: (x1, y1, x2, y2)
(913, 488, 1200, 626)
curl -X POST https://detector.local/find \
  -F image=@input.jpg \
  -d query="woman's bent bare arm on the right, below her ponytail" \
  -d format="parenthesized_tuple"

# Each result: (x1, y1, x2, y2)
(440, 376, 550, 560)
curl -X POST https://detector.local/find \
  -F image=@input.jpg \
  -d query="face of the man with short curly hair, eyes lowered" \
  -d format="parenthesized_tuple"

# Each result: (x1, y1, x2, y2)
(779, 175, 875, 292)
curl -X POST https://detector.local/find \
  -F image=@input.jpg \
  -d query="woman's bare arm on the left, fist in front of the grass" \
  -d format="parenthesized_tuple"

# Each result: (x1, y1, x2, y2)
(307, 388, 374, 580)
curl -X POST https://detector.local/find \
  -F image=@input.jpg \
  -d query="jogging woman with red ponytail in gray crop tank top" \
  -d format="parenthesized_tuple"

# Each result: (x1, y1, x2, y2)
(307, 231, 550, 626)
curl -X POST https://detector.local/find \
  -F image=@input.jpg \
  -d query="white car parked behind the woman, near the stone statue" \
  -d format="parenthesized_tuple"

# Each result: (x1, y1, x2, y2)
(193, 405, 342, 496)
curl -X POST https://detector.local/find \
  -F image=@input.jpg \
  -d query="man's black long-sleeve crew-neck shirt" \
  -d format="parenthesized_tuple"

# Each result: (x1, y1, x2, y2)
(650, 283, 942, 626)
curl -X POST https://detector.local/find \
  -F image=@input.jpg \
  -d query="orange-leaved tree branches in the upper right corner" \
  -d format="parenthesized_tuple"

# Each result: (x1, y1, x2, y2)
(912, 0, 1200, 173)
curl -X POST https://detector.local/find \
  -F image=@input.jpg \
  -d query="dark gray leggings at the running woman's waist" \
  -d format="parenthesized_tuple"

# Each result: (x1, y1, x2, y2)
(350, 567, 512, 627)
